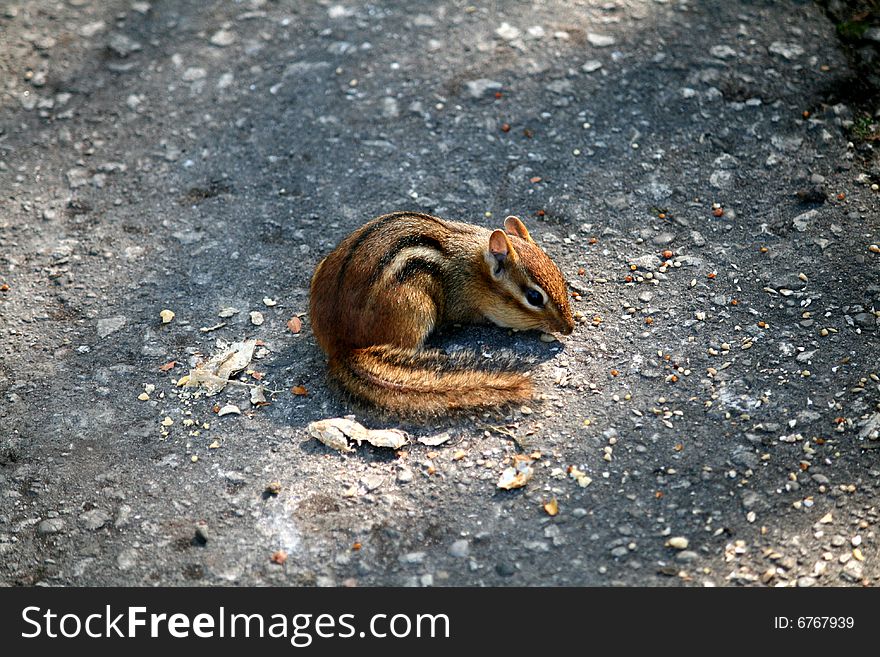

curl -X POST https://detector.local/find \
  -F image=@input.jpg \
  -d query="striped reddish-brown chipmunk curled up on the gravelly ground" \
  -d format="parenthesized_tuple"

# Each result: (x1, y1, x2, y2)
(309, 212, 574, 414)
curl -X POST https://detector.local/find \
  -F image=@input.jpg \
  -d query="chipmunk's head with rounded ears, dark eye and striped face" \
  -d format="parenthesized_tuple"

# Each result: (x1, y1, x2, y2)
(483, 217, 574, 335)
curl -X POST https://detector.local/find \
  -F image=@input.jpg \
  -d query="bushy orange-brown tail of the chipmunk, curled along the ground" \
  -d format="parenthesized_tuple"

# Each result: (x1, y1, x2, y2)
(330, 345, 532, 414)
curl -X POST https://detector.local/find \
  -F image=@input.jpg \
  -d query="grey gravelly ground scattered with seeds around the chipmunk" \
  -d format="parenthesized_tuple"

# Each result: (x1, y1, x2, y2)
(0, 0, 880, 586)
